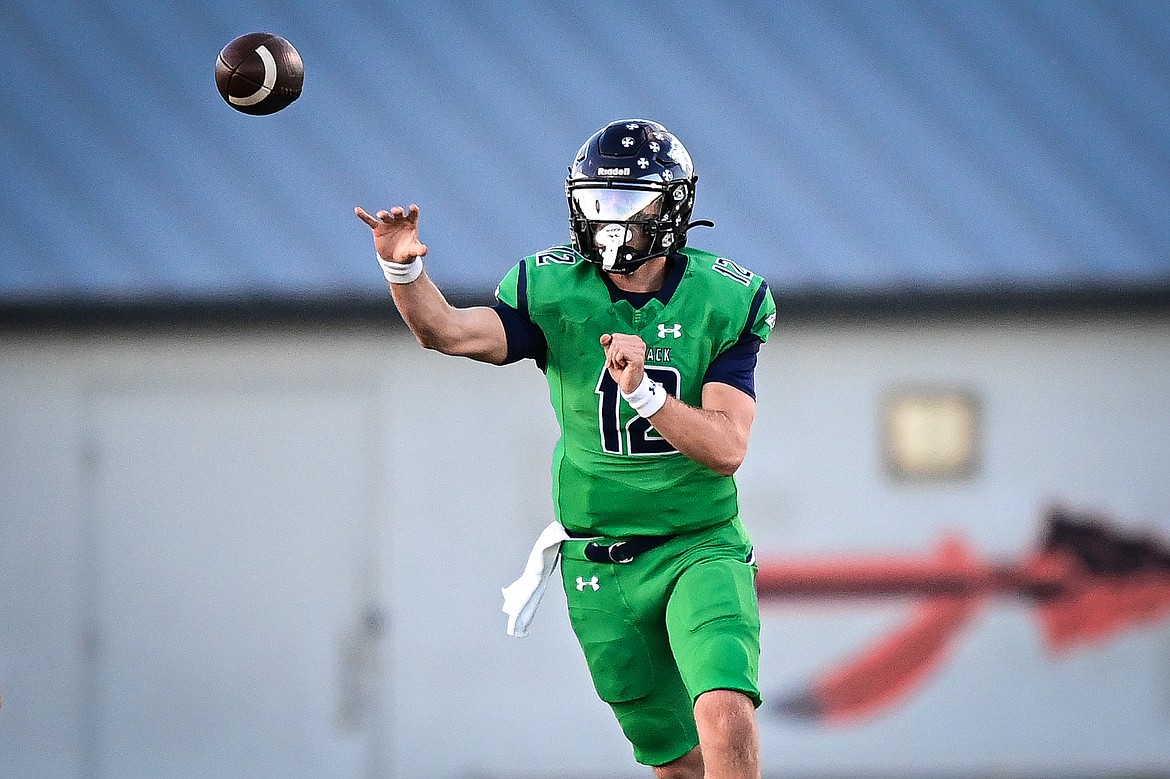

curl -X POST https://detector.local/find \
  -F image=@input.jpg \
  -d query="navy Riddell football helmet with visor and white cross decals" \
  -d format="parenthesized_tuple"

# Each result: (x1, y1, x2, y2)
(565, 119, 710, 274)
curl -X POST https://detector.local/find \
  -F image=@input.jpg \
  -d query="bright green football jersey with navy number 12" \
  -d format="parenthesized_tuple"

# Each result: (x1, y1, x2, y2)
(496, 247, 776, 537)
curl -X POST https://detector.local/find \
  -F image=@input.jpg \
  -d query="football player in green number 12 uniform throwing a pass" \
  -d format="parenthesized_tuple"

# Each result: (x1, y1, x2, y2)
(356, 119, 776, 779)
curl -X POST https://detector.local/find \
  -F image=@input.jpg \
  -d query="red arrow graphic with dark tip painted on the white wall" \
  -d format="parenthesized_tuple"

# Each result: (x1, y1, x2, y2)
(756, 509, 1170, 724)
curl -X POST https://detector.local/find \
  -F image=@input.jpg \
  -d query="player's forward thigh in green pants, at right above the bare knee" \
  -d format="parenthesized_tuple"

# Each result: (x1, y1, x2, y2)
(667, 558, 761, 705)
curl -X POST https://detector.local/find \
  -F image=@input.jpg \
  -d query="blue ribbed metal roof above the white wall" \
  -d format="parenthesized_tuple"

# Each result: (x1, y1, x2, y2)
(0, 0, 1170, 305)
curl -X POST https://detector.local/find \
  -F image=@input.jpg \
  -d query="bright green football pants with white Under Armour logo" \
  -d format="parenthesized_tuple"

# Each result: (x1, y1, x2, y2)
(560, 519, 761, 765)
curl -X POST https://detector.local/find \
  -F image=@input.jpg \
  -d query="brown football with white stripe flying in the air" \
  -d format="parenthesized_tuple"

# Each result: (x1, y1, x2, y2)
(215, 33, 304, 116)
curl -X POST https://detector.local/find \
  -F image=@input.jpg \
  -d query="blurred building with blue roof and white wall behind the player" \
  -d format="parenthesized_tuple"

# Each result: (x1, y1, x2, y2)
(0, 0, 1170, 779)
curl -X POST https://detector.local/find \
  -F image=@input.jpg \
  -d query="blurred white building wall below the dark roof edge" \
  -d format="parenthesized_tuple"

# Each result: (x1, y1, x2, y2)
(0, 318, 1170, 779)
